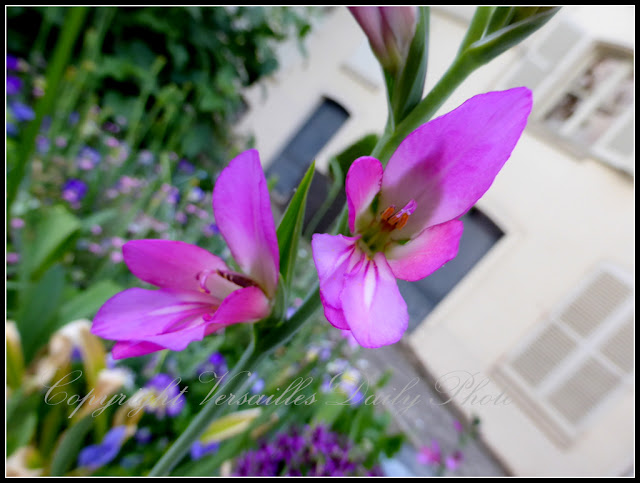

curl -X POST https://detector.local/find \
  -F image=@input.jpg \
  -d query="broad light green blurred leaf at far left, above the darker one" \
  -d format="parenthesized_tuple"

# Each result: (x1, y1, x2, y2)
(25, 205, 80, 277)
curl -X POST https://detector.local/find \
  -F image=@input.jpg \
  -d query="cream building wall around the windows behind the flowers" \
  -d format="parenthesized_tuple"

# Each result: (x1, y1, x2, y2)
(234, 7, 635, 475)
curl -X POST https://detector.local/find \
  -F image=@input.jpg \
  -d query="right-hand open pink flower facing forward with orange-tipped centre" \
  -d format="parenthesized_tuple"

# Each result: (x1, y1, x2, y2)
(312, 88, 531, 347)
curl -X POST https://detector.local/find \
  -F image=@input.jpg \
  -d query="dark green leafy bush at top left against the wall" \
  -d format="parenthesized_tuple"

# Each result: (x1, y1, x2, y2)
(7, 7, 318, 163)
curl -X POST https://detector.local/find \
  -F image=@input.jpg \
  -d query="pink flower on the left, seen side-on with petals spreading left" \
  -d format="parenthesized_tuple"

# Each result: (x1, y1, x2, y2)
(91, 150, 280, 359)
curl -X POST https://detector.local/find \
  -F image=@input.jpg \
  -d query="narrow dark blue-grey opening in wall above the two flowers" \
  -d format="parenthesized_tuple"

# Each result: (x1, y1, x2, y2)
(267, 99, 349, 208)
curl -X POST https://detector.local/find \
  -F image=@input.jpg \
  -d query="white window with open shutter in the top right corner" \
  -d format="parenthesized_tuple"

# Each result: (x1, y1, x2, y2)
(501, 14, 635, 174)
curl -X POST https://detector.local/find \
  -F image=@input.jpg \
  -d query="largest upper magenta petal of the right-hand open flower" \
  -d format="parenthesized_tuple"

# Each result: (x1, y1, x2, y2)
(381, 87, 532, 239)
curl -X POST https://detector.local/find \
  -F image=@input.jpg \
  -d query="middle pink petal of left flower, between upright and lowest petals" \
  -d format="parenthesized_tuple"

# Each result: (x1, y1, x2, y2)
(122, 240, 238, 299)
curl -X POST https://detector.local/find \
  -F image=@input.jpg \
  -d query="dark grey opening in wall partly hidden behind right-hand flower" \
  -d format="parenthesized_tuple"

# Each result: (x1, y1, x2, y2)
(398, 208, 503, 330)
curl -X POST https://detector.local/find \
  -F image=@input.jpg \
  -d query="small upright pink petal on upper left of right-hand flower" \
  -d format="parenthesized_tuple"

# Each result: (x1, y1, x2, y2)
(345, 156, 382, 233)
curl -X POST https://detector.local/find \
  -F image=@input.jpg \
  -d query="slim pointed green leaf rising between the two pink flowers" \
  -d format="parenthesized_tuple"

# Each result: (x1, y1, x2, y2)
(277, 161, 316, 287)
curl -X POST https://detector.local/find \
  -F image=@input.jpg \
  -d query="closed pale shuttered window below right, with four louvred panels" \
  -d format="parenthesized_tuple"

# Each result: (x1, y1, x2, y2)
(494, 266, 634, 447)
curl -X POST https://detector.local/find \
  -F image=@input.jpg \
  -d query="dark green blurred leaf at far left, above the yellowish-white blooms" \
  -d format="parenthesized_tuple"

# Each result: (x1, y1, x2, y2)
(16, 265, 64, 363)
